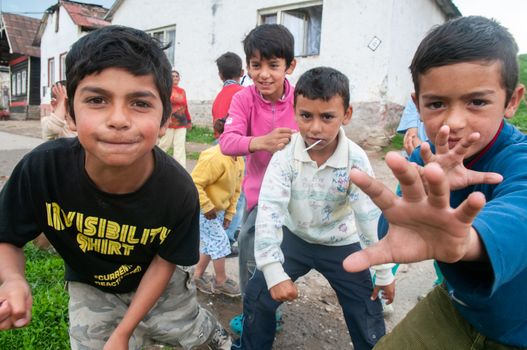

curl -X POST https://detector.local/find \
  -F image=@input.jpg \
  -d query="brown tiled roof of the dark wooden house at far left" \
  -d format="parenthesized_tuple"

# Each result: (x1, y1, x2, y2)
(2, 12, 40, 57)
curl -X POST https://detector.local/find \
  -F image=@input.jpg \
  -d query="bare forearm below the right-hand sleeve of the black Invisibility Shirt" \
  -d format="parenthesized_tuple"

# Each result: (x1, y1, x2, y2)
(104, 255, 176, 350)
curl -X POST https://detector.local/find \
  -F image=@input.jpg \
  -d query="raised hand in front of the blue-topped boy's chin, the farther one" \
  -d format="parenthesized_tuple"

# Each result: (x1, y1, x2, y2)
(420, 125, 503, 191)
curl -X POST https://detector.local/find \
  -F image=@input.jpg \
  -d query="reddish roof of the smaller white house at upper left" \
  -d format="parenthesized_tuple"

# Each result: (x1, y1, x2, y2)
(33, 0, 111, 46)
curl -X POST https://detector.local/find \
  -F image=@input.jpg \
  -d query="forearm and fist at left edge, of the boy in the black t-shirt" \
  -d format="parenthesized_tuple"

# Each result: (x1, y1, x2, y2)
(0, 243, 33, 330)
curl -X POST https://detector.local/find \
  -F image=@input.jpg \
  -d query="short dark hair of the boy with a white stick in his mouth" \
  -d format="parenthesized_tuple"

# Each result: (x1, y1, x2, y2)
(295, 67, 350, 110)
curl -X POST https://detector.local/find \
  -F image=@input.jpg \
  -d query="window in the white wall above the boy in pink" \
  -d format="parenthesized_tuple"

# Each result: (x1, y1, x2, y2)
(259, 1, 322, 56)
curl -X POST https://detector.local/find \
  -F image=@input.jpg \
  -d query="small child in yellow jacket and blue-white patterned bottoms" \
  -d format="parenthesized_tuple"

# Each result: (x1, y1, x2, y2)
(191, 118, 245, 297)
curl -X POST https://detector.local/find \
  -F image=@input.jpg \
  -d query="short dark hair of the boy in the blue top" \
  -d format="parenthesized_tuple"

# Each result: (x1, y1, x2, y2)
(410, 16, 518, 104)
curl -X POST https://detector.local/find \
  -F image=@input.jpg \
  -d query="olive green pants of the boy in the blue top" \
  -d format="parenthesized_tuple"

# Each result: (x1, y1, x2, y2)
(374, 286, 525, 350)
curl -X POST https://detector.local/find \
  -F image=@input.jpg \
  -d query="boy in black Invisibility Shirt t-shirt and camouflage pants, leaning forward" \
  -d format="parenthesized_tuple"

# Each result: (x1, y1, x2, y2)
(0, 26, 231, 349)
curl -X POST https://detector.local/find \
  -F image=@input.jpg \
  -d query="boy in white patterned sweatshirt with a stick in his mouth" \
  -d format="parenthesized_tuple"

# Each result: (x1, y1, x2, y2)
(233, 67, 395, 350)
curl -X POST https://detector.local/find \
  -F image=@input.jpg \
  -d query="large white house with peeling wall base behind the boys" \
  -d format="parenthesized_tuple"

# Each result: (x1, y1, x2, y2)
(106, 0, 460, 146)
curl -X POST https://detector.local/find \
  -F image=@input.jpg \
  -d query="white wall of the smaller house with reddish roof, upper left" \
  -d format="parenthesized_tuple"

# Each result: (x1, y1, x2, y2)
(39, 7, 83, 116)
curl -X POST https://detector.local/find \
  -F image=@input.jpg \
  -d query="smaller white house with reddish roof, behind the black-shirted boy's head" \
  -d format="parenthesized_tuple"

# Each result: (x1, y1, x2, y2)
(33, 0, 110, 116)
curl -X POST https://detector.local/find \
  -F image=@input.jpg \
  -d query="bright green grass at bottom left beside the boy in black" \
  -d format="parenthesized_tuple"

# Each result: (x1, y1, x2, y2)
(0, 244, 70, 349)
